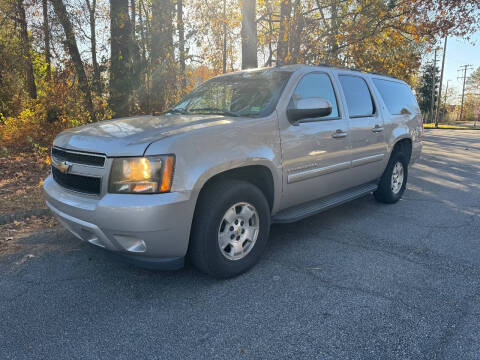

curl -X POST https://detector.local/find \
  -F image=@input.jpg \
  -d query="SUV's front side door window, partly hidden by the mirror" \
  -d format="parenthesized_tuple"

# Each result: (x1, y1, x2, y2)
(292, 73, 338, 118)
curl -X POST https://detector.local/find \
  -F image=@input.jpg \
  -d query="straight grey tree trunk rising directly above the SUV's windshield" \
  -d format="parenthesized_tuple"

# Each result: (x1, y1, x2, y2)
(241, 0, 258, 69)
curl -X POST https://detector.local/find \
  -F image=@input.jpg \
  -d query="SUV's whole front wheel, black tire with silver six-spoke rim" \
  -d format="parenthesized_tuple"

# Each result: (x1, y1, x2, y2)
(189, 180, 270, 277)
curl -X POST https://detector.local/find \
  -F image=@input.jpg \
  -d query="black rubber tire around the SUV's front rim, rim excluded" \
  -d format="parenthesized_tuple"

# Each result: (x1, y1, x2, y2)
(189, 180, 270, 278)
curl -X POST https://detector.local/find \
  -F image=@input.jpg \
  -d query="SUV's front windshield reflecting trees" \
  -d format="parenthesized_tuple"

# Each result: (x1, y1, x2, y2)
(167, 70, 291, 117)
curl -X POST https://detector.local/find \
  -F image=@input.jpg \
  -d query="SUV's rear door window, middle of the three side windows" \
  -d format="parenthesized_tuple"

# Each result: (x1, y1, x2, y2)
(339, 75, 375, 117)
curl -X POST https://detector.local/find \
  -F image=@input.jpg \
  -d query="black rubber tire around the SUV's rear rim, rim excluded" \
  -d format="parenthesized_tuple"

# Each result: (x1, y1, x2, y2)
(373, 151, 408, 204)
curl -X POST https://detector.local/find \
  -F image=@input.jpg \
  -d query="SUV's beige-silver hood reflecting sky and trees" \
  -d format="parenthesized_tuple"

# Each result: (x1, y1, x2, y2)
(53, 114, 233, 156)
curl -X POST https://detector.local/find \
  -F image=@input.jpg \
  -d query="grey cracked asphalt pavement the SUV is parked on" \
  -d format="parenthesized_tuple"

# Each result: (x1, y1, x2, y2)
(0, 130, 480, 359)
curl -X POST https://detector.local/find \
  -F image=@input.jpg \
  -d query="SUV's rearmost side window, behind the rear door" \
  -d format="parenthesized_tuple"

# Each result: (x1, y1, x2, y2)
(373, 79, 418, 115)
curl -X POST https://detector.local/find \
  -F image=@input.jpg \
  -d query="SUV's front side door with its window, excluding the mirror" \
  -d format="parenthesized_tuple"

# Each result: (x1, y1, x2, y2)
(278, 72, 351, 208)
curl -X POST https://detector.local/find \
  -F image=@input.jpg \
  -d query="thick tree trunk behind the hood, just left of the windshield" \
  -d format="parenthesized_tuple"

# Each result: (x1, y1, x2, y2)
(151, 0, 175, 112)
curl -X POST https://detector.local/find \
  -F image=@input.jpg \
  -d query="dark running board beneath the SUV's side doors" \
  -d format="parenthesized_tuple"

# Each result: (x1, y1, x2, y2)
(272, 183, 378, 223)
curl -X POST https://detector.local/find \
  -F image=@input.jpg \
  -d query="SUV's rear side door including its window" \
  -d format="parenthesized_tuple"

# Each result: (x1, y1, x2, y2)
(338, 74, 387, 186)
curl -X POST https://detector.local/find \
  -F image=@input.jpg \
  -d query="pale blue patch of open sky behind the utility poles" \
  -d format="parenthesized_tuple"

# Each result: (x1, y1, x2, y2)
(430, 31, 480, 102)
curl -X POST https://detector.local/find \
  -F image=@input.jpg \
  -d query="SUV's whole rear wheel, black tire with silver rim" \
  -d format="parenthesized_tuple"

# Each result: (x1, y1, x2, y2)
(374, 151, 408, 204)
